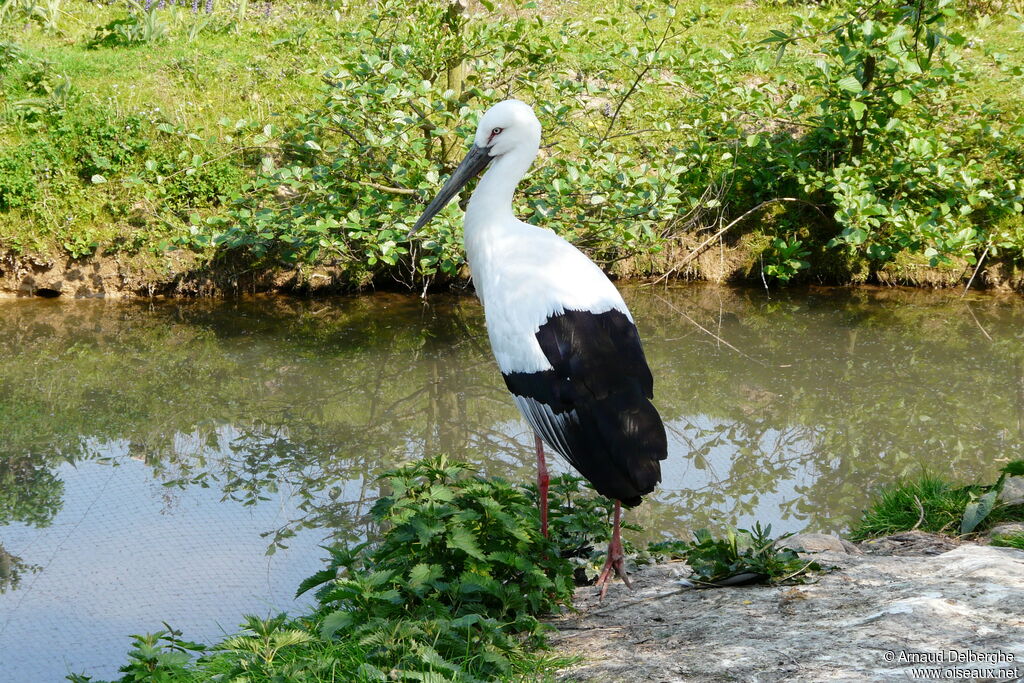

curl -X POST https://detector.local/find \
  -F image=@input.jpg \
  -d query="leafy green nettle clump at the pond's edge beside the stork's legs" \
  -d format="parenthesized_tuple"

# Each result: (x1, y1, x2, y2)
(299, 456, 573, 680)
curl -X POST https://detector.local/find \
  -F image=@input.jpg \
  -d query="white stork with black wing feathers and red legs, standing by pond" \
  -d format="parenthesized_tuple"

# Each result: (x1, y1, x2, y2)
(410, 99, 667, 598)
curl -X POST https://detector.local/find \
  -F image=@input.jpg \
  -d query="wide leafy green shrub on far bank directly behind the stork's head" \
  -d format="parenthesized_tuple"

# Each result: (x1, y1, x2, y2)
(193, 0, 681, 279)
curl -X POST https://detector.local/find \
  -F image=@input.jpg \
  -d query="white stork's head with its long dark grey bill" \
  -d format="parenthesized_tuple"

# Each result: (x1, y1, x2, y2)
(409, 99, 541, 237)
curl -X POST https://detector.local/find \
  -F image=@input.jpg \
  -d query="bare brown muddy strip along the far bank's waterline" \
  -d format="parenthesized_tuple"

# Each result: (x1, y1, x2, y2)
(0, 246, 1024, 298)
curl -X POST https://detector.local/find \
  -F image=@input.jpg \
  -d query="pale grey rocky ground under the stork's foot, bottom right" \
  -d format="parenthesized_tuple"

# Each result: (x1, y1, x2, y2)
(552, 531, 1024, 683)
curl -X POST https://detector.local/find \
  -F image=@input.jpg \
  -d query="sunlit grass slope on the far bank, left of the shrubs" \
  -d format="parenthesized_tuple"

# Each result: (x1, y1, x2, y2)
(0, 1, 333, 260)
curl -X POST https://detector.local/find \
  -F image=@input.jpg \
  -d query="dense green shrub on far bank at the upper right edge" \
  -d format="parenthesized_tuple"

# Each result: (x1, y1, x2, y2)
(749, 0, 1024, 272)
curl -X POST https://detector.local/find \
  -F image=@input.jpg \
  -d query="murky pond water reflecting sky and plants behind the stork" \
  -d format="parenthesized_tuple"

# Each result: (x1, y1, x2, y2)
(0, 286, 1024, 681)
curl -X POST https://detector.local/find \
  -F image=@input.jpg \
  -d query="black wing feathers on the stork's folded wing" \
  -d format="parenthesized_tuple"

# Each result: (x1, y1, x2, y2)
(505, 310, 668, 506)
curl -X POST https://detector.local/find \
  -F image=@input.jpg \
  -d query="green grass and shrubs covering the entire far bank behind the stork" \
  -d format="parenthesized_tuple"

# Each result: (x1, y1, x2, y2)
(0, 0, 1024, 289)
